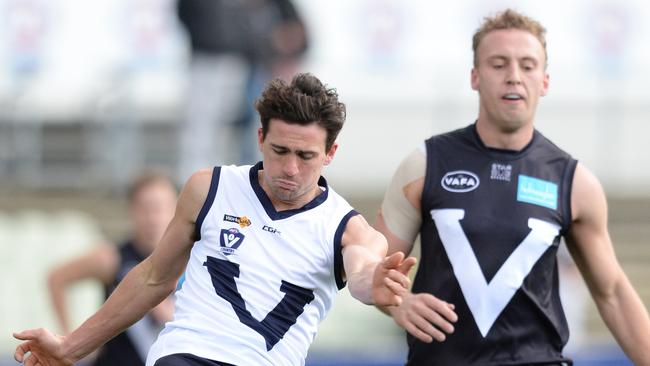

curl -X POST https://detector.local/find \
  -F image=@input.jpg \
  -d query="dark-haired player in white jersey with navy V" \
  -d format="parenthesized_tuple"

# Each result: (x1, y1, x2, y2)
(14, 74, 415, 366)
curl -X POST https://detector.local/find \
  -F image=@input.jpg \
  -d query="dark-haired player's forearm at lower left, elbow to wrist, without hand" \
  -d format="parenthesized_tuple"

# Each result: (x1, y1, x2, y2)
(64, 260, 174, 360)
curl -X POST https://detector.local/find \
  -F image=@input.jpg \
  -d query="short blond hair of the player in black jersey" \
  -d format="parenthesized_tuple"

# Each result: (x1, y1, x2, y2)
(472, 9, 548, 67)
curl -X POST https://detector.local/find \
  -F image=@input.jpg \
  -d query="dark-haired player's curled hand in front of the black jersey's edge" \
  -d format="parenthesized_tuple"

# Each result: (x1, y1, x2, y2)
(372, 252, 417, 306)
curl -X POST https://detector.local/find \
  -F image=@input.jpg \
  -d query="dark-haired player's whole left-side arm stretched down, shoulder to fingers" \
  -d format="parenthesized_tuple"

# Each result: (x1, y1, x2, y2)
(14, 170, 212, 365)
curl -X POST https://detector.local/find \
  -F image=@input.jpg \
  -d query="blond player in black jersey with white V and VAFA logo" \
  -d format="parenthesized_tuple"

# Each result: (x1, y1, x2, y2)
(376, 10, 650, 365)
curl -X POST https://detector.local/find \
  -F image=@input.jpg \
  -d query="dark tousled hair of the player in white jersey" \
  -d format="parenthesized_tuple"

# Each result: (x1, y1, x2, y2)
(255, 74, 345, 151)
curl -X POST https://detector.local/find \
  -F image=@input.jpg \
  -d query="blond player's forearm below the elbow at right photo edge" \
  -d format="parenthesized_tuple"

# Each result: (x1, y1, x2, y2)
(595, 279, 650, 366)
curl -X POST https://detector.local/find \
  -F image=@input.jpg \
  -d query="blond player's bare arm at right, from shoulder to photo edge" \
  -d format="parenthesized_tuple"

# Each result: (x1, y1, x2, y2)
(567, 164, 650, 365)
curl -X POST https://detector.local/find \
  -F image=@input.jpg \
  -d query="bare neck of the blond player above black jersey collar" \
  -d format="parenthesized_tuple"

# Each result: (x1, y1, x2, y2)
(476, 118, 535, 151)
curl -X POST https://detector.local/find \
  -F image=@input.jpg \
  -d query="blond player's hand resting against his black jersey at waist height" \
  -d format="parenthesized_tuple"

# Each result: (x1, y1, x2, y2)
(388, 293, 458, 343)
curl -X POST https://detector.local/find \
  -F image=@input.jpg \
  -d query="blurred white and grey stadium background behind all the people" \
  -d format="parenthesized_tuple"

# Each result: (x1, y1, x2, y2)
(0, 0, 650, 366)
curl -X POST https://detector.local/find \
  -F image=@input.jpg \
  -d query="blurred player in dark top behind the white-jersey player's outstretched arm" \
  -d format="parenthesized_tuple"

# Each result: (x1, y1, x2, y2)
(49, 172, 177, 366)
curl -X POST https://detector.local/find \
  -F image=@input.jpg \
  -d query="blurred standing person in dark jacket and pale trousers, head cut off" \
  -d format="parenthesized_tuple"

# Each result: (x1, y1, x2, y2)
(177, 0, 307, 181)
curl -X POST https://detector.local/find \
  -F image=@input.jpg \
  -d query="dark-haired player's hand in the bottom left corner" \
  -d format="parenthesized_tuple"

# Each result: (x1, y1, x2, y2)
(14, 328, 74, 366)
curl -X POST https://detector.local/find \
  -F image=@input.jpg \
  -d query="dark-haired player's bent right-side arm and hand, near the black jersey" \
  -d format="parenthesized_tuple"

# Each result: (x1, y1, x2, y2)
(341, 215, 416, 305)
